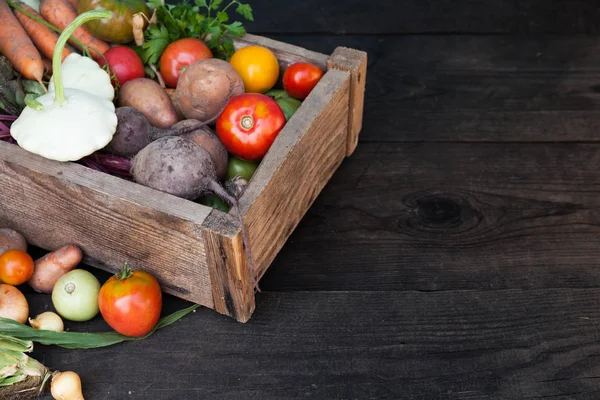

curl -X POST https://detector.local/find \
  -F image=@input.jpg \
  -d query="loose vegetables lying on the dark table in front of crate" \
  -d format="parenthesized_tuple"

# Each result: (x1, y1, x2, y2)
(0, 228, 198, 400)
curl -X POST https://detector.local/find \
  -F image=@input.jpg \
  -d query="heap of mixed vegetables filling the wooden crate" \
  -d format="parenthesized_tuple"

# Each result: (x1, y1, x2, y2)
(0, 0, 323, 289)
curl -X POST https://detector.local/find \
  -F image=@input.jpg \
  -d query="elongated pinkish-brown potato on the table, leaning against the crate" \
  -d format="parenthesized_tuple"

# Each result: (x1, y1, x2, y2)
(27, 244, 83, 294)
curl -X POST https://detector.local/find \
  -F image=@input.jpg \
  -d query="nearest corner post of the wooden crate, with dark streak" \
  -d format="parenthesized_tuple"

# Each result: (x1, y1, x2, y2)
(202, 210, 255, 322)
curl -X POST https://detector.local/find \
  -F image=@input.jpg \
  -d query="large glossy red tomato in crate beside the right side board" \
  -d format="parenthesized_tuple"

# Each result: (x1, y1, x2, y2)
(216, 93, 285, 161)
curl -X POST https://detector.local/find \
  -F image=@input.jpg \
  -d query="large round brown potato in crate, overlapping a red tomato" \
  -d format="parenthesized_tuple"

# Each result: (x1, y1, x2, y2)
(175, 58, 245, 122)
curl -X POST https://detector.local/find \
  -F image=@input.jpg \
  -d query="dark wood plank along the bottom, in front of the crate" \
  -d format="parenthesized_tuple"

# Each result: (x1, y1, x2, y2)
(30, 288, 600, 400)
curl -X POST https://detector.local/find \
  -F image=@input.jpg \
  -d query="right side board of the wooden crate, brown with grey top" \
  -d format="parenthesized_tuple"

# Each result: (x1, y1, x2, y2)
(240, 70, 350, 277)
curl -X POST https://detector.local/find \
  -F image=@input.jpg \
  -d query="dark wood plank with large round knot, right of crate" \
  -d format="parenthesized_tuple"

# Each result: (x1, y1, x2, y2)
(261, 143, 600, 291)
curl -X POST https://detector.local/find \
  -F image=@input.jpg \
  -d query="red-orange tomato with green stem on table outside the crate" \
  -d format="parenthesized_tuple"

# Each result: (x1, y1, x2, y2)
(98, 264, 162, 337)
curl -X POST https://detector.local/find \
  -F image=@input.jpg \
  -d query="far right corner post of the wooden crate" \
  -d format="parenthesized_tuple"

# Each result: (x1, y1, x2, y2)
(327, 47, 368, 156)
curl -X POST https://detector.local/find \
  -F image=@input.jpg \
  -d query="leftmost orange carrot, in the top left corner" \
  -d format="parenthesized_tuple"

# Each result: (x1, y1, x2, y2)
(0, 0, 44, 86)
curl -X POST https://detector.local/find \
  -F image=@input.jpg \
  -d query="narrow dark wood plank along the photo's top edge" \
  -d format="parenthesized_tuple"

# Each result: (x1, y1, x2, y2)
(224, 0, 600, 35)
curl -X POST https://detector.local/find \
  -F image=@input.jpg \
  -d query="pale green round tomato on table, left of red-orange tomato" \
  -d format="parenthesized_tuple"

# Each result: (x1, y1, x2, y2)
(52, 269, 100, 322)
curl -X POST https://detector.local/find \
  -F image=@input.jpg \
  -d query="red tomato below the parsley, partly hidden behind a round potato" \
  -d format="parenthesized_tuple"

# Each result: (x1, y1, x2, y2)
(160, 38, 213, 88)
